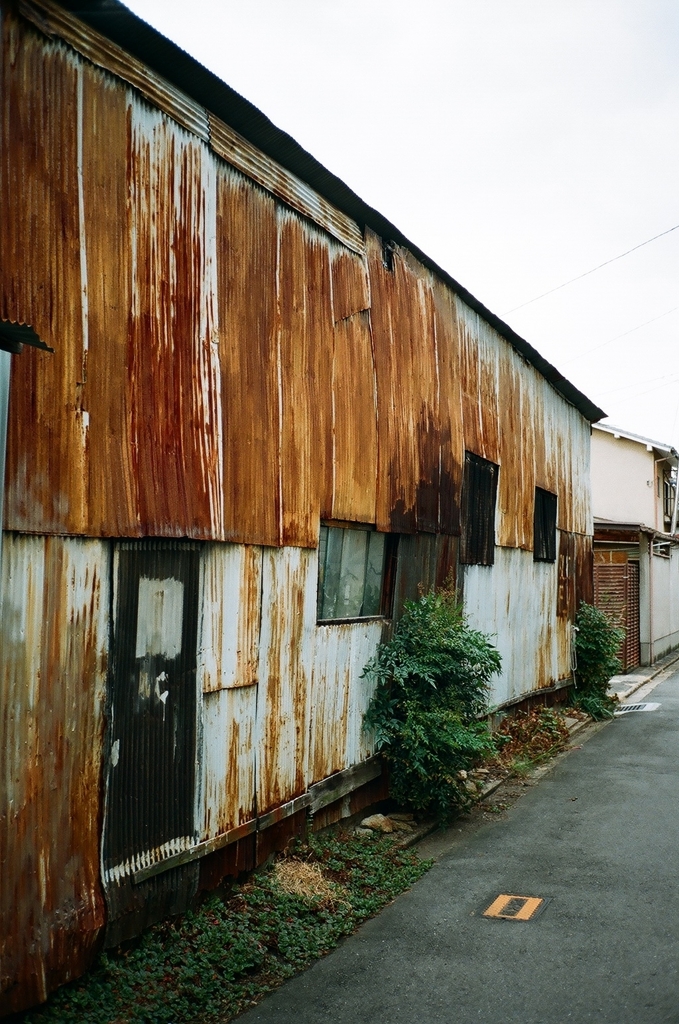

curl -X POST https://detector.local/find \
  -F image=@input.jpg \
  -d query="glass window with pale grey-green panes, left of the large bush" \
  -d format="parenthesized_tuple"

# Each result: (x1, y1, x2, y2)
(317, 525, 397, 622)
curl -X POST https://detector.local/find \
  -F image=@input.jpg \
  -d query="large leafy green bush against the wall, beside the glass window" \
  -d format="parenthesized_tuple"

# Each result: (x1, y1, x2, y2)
(364, 588, 500, 819)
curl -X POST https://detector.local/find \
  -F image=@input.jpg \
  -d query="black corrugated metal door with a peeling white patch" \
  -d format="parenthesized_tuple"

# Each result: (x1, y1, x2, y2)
(103, 541, 199, 884)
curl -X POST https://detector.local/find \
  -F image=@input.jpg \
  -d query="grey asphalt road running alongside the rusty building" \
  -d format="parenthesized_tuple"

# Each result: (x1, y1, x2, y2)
(239, 672, 679, 1024)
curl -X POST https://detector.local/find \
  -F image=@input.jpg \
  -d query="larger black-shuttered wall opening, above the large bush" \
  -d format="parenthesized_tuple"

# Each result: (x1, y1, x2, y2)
(460, 452, 499, 565)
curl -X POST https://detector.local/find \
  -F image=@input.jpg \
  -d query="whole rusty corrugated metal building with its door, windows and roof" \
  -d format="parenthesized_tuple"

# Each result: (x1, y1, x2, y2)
(0, 0, 602, 1013)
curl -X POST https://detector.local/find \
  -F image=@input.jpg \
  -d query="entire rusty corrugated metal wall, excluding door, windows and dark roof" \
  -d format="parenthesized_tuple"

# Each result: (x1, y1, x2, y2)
(0, 0, 591, 1010)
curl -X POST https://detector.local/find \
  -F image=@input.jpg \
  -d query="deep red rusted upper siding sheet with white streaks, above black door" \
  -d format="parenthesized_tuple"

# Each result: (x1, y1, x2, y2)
(128, 102, 223, 538)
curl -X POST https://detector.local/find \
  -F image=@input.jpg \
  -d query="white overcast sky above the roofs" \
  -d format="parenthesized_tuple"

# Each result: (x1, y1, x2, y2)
(127, 0, 679, 447)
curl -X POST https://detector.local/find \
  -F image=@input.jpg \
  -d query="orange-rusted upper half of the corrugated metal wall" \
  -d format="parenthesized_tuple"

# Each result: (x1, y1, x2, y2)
(0, 6, 589, 550)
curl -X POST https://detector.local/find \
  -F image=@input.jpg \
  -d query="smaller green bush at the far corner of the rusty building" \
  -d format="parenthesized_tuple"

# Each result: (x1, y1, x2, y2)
(574, 601, 625, 718)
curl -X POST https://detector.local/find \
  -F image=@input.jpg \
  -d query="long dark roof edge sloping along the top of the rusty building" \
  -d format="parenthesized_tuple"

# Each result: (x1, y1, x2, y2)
(56, 0, 606, 423)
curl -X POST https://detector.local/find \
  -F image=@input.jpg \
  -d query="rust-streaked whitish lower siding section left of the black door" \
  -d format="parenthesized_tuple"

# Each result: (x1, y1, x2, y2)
(0, 534, 110, 1013)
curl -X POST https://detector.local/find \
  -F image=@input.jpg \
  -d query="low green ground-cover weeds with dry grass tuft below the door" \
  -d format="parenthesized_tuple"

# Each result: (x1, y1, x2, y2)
(23, 830, 431, 1024)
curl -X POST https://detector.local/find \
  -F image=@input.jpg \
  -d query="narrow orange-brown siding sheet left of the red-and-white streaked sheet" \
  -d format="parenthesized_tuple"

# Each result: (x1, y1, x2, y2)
(79, 63, 139, 537)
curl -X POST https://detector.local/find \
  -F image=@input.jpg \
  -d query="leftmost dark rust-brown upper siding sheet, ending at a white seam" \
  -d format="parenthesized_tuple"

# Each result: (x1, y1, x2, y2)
(0, 22, 87, 534)
